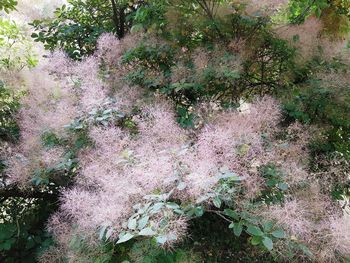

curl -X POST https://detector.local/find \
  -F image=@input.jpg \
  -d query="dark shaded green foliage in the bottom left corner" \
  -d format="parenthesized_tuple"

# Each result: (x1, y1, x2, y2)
(0, 198, 57, 263)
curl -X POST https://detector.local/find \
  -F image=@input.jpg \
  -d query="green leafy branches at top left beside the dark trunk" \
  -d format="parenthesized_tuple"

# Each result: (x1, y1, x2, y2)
(32, 0, 142, 59)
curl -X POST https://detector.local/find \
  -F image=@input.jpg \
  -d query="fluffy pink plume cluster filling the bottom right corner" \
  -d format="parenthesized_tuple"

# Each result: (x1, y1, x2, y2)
(263, 186, 350, 262)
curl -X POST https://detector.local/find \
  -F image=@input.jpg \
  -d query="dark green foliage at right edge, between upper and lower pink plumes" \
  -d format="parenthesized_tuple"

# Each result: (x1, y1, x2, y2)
(284, 75, 350, 158)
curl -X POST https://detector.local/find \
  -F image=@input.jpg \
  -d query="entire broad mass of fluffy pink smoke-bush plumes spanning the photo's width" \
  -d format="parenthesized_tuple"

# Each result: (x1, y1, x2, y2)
(7, 35, 344, 261)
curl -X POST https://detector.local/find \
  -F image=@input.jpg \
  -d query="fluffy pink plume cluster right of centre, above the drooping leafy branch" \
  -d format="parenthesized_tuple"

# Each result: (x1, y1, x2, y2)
(183, 97, 280, 197)
